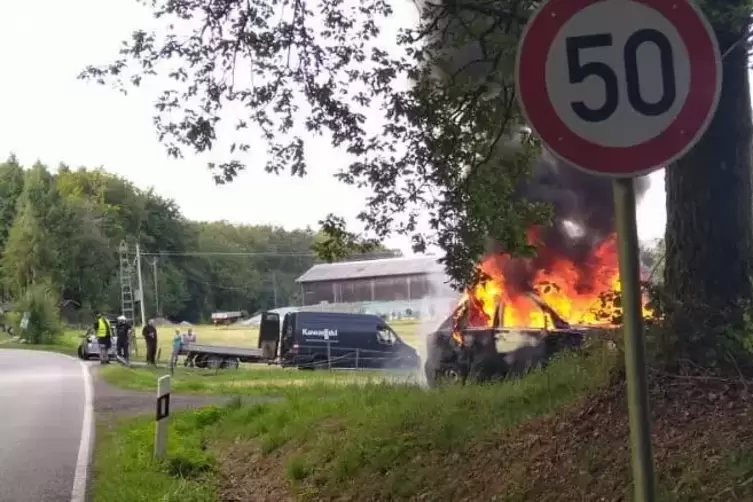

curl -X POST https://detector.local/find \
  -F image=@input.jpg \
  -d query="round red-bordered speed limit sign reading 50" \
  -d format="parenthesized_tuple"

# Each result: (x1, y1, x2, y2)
(516, 0, 722, 177)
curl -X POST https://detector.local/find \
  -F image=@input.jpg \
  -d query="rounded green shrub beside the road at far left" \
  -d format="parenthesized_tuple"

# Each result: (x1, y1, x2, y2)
(14, 283, 62, 344)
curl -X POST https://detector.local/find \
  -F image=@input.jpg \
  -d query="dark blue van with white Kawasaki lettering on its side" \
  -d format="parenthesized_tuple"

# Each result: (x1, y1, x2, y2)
(259, 312, 420, 369)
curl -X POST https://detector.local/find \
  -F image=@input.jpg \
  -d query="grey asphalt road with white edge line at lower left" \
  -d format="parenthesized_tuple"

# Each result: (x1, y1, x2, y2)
(0, 349, 93, 502)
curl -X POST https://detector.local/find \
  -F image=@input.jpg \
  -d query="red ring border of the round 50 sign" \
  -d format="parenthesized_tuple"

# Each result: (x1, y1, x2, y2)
(515, 0, 722, 177)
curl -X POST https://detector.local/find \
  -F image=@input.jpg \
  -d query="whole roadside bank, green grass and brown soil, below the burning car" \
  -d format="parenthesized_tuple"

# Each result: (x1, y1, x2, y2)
(94, 340, 753, 502)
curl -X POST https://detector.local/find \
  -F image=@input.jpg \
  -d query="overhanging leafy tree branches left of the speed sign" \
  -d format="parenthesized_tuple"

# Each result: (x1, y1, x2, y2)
(81, 0, 547, 284)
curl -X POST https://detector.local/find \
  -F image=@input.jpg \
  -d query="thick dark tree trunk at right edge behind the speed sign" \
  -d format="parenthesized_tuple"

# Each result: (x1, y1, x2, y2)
(660, 12, 753, 372)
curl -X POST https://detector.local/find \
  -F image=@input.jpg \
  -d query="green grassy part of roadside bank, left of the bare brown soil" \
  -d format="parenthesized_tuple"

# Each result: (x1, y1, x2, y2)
(95, 353, 614, 502)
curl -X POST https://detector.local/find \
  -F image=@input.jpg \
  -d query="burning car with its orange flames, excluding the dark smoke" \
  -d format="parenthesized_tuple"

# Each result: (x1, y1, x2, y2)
(424, 229, 651, 386)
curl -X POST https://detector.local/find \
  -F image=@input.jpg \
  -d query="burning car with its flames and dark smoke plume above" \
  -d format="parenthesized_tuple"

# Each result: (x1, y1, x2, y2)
(425, 150, 652, 385)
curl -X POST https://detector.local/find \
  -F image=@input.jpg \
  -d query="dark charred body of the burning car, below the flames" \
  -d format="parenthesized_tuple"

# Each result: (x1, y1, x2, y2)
(424, 294, 589, 387)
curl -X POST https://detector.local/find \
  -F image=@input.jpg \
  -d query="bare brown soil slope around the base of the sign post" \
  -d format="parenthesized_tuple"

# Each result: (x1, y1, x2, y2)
(466, 376, 753, 502)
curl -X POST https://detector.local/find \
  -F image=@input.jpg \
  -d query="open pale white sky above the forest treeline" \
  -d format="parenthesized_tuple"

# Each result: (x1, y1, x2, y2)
(0, 0, 666, 252)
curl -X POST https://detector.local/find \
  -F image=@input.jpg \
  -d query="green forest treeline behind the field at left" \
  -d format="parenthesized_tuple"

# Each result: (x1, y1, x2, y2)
(0, 156, 346, 322)
